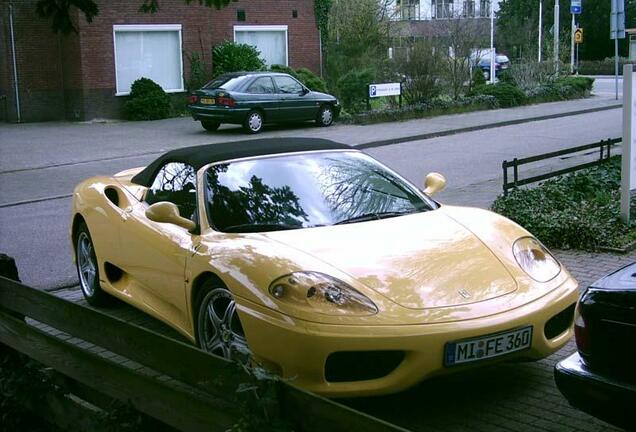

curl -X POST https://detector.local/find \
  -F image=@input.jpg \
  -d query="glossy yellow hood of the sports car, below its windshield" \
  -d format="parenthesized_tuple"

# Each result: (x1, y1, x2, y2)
(265, 211, 517, 309)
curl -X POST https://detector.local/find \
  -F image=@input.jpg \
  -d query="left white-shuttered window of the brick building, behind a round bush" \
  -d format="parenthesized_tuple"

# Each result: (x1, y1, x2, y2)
(113, 24, 184, 96)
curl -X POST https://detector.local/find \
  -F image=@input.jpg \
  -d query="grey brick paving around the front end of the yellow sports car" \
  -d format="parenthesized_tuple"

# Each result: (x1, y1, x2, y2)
(346, 250, 636, 432)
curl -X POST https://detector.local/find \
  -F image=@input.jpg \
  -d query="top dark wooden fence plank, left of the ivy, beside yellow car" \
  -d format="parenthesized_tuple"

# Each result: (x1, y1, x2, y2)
(0, 277, 243, 398)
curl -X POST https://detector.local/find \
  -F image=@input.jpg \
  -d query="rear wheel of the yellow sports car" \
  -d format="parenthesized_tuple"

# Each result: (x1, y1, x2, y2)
(75, 222, 110, 306)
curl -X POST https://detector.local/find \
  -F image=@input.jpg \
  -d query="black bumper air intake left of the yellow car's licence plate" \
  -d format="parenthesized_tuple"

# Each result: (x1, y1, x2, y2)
(325, 351, 405, 382)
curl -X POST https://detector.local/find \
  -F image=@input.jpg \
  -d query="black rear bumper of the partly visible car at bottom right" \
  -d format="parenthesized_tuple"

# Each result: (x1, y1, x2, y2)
(554, 353, 636, 430)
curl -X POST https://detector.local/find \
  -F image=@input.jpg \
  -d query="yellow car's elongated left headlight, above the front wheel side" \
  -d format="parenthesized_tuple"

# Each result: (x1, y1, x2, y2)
(269, 271, 378, 315)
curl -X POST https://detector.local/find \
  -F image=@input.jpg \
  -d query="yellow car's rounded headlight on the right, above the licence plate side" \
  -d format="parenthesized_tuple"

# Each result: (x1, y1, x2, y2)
(512, 237, 561, 282)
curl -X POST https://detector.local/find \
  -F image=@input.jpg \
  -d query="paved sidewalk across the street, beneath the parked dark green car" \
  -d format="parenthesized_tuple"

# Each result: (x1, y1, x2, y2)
(0, 96, 621, 174)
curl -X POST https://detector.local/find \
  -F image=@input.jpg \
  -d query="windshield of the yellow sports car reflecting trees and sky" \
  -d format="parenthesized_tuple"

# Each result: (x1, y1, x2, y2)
(205, 152, 437, 232)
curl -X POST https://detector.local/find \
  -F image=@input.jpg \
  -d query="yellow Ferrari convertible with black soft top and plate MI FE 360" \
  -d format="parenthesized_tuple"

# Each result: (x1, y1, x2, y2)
(70, 138, 578, 396)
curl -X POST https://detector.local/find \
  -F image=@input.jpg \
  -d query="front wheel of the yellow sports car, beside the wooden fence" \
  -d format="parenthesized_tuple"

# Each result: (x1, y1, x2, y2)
(196, 280, 250, 364)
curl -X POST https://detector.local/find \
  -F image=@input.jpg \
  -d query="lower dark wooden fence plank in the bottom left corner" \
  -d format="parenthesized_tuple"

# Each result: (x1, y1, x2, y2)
(0, 312, 239, 432)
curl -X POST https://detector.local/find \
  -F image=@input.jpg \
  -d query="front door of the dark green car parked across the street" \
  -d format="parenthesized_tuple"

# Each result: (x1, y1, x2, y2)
(273, 75, 318, 121)
